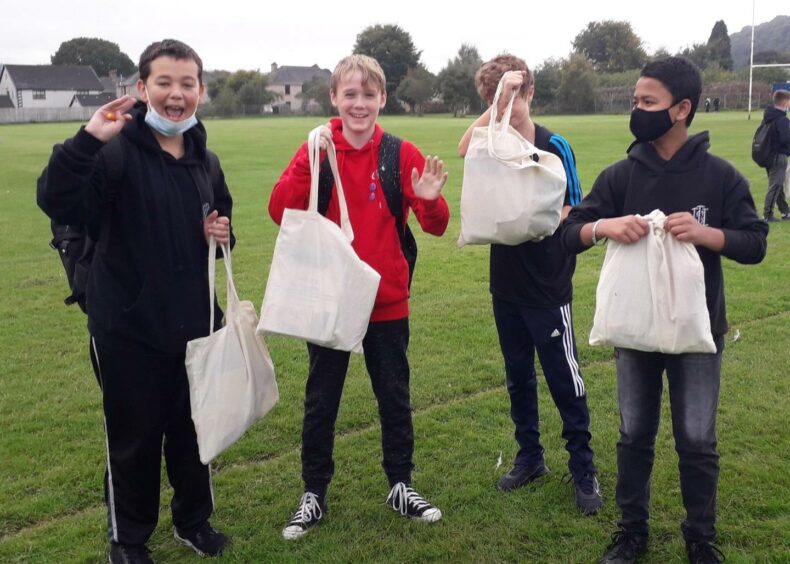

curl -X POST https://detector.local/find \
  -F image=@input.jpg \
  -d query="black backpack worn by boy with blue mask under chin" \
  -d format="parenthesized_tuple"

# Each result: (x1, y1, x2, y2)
(49, 136, 220, 313)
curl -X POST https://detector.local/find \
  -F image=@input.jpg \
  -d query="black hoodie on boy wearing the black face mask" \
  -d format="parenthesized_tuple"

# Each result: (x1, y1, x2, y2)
(562, 131, 768, 336)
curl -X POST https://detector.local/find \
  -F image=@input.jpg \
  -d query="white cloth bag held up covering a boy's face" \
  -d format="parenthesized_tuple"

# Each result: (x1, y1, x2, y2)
(458, 76, 566, 248)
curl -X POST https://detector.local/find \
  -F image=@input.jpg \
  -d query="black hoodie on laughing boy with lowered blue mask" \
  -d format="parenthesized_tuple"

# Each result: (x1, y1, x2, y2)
(38, 103, 232, 354)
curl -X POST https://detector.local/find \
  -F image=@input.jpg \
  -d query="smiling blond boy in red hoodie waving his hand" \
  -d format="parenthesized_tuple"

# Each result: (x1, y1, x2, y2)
(269, 55, 450, 540)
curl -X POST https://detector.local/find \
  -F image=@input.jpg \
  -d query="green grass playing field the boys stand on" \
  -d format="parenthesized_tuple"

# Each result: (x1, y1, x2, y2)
(0, 113, 790, 563)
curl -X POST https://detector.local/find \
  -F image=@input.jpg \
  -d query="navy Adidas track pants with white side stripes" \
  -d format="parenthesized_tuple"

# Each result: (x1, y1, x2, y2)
(493, 298, 596, 481)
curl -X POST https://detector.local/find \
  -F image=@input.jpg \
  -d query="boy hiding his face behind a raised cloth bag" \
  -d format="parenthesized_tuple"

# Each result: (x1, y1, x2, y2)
(458, 54, 603, 515)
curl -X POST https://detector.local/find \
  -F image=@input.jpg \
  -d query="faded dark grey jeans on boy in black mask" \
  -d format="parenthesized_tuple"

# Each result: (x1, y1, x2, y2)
(615, 336, 724, 541)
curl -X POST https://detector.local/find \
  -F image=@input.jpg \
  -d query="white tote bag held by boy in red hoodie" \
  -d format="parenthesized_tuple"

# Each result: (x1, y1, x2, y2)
(258, 128, 381, 352)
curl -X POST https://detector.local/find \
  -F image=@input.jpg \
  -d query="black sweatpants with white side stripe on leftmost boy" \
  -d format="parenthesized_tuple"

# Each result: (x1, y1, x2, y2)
(91, 339, 214, 544)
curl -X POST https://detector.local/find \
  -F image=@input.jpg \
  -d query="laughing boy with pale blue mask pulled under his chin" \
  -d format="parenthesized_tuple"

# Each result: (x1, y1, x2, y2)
(38, 39, 234, 563)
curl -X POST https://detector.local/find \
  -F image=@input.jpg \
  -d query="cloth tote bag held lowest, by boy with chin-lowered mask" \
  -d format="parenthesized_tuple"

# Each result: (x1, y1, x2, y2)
(186, 237, 280, 464)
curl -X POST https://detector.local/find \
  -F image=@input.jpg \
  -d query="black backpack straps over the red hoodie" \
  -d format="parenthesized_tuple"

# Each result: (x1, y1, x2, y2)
(318, 132, 417, 288)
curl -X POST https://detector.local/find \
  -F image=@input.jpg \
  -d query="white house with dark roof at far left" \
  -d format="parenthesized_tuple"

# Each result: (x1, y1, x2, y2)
(0, 65, 104, 108)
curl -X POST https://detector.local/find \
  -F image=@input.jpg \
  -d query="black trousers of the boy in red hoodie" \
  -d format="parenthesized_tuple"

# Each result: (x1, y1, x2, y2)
(302, 318, 414, 496)
